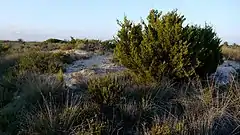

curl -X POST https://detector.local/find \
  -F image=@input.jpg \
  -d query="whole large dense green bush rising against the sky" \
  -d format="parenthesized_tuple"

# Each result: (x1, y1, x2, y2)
(115, 10, 222, 80)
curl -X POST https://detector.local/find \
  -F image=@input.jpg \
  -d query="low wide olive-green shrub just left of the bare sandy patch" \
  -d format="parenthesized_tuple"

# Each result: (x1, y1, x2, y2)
(18, 52, 71, 73)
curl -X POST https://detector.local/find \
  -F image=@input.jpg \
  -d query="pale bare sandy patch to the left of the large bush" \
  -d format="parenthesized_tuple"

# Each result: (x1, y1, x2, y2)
(64, 50, 125, 89)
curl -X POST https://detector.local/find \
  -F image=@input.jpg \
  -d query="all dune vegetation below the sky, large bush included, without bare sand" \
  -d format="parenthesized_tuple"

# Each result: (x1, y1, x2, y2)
(0, 10, 240, 135)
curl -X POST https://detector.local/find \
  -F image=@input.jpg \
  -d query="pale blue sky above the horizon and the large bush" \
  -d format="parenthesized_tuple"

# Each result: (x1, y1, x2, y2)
(0, 0, 240, 43)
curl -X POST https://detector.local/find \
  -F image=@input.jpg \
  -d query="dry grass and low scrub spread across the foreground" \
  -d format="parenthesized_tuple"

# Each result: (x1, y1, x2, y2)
(0, 71, 240, 135)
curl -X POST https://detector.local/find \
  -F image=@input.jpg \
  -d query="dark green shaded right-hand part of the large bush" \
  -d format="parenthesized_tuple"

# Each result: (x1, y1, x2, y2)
(185, 24, 223, 77)
